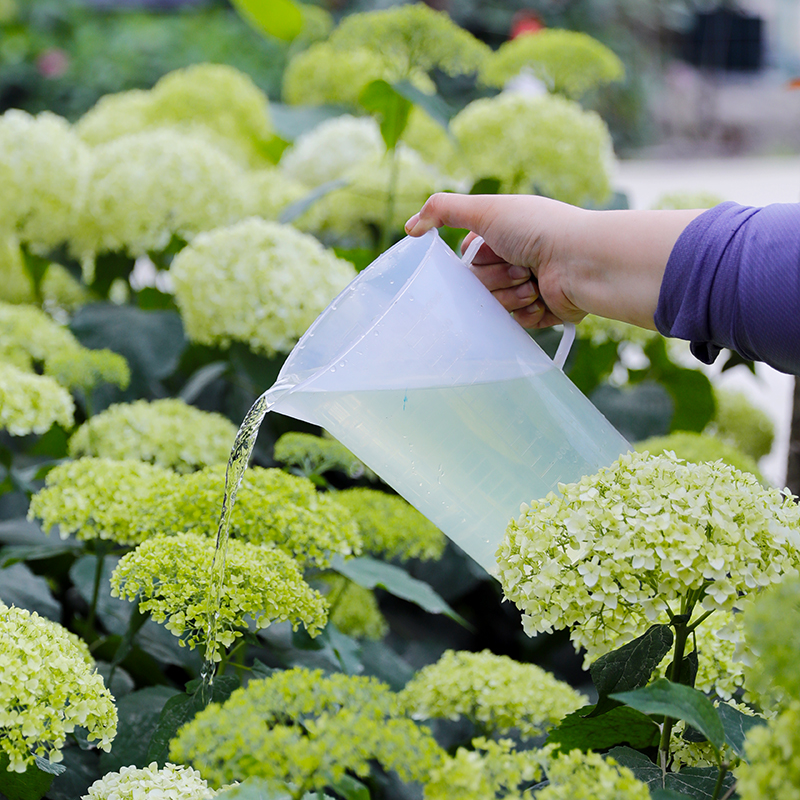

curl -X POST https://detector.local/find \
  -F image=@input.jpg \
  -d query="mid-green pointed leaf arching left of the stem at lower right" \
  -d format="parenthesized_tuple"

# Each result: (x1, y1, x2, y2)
(611, 678, 725, 753)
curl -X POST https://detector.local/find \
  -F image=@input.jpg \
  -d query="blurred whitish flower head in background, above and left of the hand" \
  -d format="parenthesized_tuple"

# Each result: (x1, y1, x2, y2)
(280, 114, 386, 188)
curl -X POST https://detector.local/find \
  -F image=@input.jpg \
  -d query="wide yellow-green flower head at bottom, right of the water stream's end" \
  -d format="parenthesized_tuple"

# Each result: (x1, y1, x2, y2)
(170, 668, 444, 798)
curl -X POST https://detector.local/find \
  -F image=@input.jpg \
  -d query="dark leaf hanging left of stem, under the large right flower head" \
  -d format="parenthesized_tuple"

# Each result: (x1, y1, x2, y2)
(589, 625, 674, 716)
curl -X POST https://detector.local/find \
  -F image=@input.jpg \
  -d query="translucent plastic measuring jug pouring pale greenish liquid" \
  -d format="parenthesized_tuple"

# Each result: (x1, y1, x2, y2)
(268, 230, 629, 574)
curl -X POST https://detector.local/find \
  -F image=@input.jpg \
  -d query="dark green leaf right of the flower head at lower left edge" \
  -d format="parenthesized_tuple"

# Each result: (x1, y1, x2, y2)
(100, 686, 180, 772)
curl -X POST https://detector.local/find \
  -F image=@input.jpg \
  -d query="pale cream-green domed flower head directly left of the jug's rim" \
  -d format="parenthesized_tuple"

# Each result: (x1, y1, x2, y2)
(170, 219, 355, 356)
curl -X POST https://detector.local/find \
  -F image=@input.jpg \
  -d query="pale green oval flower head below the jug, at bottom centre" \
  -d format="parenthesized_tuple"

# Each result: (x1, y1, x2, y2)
(400, 650, 588, 737)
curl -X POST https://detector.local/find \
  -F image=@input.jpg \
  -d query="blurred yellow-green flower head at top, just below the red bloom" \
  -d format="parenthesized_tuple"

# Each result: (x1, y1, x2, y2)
(481, 28, 625, 100)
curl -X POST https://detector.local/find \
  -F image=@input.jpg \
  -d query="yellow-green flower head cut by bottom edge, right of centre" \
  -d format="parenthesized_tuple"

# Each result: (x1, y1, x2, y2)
(536, 750, 650, 800)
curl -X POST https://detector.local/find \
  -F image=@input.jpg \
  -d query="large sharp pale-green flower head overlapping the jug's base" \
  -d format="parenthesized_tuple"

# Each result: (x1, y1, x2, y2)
(498, 453, 800, 664)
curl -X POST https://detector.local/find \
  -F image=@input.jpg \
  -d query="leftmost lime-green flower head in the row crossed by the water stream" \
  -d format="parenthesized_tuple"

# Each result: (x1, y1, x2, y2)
(28, 458, 178, 545)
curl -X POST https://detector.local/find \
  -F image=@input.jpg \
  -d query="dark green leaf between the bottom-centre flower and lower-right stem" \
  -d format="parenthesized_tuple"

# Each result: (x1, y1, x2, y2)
(547, 706, 660, 753)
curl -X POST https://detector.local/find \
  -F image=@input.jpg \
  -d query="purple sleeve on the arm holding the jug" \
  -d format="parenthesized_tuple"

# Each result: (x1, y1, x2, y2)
(655, 203, 800, 374)
